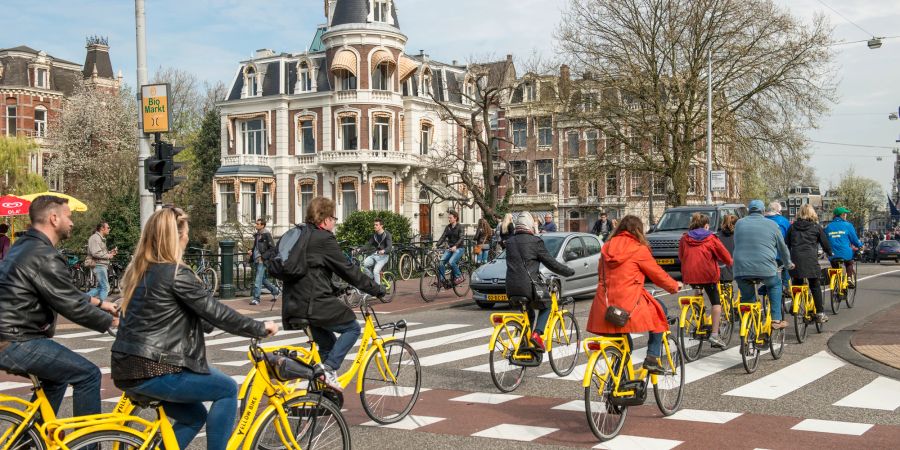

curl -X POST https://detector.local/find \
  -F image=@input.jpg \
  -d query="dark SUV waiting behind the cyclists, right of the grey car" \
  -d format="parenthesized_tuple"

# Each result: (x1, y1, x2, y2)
(647, 204, 747, 272)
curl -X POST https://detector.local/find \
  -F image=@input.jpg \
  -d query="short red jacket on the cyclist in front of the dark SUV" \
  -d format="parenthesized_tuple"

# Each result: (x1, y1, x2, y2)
(678, 230, 734, 284)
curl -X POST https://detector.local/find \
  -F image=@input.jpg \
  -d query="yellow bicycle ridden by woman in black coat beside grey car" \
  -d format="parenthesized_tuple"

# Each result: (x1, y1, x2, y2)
(488, 277, 581, 392)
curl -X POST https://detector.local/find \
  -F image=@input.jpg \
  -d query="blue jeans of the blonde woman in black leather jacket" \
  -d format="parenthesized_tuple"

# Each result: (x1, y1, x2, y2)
(129, 367, 238, 450)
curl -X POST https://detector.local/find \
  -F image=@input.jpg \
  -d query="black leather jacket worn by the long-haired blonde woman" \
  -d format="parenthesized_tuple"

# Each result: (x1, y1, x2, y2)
(111, 263, 266, 372)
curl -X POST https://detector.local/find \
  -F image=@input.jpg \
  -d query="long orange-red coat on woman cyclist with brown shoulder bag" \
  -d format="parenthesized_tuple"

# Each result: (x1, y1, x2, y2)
(587, 233, 678, 334)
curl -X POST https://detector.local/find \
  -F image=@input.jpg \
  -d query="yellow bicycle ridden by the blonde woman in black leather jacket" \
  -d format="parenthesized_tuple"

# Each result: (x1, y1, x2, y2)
(46, 339, 350, 450)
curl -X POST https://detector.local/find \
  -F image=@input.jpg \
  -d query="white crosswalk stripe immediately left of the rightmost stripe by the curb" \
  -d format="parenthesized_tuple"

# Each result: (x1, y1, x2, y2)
(724, 350, 844, 400)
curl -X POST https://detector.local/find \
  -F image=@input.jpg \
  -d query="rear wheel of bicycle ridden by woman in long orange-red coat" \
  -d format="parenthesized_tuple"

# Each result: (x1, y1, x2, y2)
(584, 347, 628, 441)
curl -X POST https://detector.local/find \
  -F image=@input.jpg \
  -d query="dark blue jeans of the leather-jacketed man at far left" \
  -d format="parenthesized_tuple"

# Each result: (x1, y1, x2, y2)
(0, 338, 101, 416)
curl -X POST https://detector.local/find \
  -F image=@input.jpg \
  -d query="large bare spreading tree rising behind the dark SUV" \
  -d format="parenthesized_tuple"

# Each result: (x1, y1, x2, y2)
(556, 0, 835, 204)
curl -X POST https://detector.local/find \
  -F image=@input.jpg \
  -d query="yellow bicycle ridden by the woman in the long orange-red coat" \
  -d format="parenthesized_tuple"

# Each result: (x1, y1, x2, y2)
(581, 331, 684, 441)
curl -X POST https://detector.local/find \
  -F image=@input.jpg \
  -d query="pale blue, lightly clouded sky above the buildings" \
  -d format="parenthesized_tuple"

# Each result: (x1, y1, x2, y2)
(7, 0, 900, 197)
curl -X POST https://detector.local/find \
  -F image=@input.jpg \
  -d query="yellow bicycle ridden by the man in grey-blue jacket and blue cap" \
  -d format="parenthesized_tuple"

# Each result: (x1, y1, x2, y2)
(738, 279, 784, 373)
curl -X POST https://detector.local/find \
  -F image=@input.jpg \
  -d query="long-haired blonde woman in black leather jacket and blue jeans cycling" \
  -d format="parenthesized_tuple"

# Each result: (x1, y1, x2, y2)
(111, 208, 278, 449)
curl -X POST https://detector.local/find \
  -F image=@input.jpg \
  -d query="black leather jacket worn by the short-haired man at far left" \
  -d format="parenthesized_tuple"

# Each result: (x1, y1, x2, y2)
(0, 228, 113, 341)
